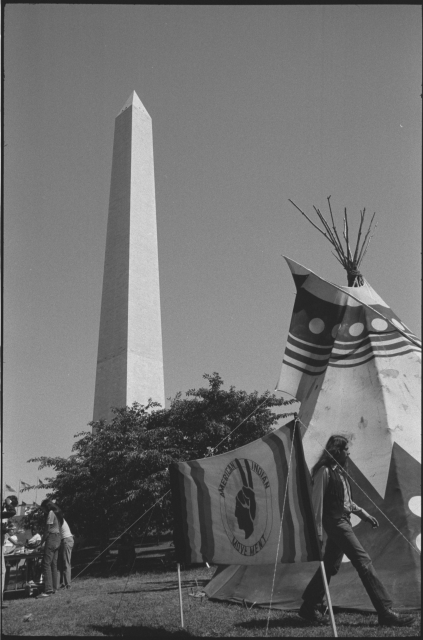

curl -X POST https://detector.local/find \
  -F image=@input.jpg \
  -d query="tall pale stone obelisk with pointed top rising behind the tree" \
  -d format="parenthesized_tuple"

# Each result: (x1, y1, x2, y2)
(93, 91, 165, 420)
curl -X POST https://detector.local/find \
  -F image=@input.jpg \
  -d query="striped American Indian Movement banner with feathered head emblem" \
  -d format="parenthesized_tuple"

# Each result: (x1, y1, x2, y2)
(170, 421, 320, 564)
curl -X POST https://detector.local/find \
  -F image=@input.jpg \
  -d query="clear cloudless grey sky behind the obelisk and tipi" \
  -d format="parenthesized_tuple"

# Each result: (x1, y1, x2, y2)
(3, 4, 422, 501)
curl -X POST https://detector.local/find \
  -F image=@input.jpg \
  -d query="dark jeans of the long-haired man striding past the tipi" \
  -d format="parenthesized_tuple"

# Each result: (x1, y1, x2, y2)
(302, 516, 392, 614)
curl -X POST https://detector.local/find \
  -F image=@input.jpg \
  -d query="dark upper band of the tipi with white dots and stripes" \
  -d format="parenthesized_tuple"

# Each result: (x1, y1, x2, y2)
(278, 260, 421, 378)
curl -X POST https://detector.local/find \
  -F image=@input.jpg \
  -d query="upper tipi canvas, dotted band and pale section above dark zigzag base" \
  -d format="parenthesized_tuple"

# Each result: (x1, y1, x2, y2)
(277, 259, 421, 497)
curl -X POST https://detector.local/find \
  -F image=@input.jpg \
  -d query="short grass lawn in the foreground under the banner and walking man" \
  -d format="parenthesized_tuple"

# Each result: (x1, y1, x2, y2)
(2, 568, 420, 640)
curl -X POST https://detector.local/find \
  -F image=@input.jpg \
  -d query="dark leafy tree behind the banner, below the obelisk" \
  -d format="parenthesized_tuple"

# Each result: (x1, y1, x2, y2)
(25, 373, 294, 546)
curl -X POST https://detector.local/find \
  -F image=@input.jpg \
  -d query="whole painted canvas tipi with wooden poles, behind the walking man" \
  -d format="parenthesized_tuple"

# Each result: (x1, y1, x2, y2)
(205, 200, 421, 610)
